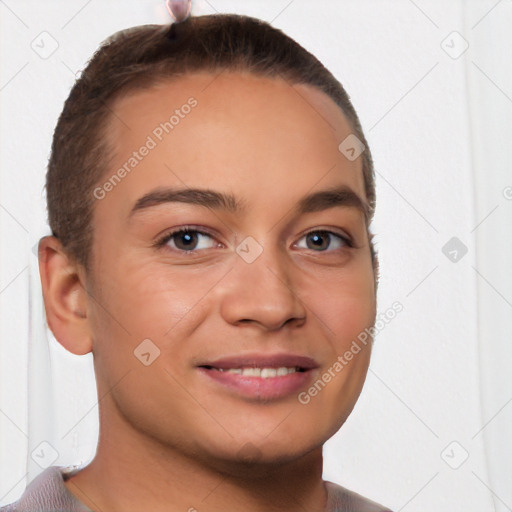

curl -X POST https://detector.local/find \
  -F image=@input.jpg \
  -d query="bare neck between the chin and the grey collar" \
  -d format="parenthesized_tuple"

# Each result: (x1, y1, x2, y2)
(65, 400, 327, 512)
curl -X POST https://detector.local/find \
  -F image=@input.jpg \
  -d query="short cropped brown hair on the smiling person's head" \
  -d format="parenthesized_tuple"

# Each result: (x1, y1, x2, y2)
(46, 14, 378, 285)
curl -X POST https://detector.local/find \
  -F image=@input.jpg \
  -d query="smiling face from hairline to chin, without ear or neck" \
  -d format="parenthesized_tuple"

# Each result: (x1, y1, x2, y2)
(87, 73, 376, 472)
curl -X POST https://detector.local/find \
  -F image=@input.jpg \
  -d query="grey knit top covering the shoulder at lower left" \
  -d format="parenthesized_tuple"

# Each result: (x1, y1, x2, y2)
(0, 466, 91, 512)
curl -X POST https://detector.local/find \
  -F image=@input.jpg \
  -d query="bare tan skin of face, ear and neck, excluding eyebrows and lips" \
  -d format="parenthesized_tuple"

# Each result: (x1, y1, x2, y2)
(40, 73, 376, 512)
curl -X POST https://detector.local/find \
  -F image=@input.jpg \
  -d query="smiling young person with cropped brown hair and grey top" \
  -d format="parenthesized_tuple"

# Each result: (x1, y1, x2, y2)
(2, 11, 387, 512)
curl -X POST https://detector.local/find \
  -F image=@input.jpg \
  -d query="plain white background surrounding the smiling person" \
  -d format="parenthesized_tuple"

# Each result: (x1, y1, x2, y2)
(0, 0, 512, 512)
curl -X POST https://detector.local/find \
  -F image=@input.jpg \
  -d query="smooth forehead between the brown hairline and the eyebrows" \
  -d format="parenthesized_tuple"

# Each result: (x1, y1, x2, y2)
(100, 72, 365, 218)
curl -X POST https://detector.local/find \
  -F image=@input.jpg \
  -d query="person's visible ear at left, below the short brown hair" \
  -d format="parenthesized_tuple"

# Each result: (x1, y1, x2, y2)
(39, 236, 92, 355)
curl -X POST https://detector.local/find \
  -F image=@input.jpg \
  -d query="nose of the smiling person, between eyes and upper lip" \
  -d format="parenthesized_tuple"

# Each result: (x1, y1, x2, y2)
(221, 241, 306, 331)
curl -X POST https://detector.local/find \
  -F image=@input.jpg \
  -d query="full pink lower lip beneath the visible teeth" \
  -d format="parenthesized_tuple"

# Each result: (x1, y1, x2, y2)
(198, 368, 313, 400)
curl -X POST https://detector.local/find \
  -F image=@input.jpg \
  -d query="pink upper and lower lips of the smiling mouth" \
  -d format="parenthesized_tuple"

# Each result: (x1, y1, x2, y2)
(197, 353, 319, 401)
